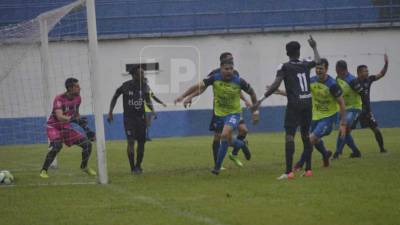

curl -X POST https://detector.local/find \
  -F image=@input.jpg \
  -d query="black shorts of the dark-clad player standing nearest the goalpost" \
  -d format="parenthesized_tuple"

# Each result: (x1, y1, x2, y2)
(124, 118, 147, 142)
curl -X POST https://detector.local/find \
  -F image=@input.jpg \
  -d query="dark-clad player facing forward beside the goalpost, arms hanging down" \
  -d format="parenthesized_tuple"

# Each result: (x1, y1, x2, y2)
(108, 66, 153, 174)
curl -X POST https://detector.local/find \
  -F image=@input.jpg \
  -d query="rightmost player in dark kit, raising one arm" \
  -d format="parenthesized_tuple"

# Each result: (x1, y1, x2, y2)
(353, 54, 389, 153)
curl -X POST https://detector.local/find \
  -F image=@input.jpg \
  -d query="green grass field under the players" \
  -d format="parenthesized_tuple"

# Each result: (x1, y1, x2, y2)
(0, 128, 400, 225)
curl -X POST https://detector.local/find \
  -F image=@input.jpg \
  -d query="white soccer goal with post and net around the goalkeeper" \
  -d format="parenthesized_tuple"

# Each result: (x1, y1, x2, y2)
(0, 0, 108, 184)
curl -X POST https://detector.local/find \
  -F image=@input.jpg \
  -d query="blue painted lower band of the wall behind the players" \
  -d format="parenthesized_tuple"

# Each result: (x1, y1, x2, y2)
(0, 101, 400, 145)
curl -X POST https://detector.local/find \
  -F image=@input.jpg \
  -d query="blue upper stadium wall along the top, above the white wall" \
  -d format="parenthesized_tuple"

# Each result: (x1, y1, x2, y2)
(0, 0, 400, 38)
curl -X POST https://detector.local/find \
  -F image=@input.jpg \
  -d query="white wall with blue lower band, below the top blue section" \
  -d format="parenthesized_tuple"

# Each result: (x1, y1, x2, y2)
(0, 29, 400, 143)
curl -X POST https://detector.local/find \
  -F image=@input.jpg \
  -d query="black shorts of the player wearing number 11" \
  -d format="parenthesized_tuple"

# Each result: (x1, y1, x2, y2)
(284, 104, 312, 133)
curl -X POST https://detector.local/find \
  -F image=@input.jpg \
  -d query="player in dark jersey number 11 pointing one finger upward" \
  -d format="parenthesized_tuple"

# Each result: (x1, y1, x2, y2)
(254, 36, 320, 180)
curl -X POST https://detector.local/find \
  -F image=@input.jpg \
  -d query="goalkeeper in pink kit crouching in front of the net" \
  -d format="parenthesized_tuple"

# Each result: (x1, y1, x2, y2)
(40, 78, 97, 178)
